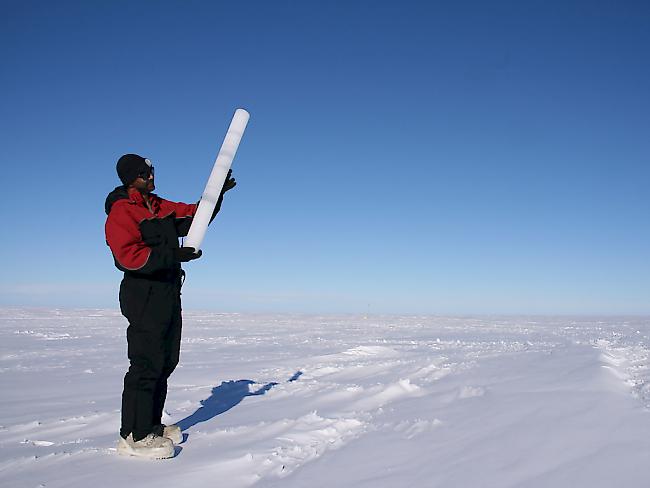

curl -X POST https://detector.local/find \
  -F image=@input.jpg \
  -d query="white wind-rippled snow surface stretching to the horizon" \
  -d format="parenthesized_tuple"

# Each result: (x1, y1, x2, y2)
(0, 309, 650, 488)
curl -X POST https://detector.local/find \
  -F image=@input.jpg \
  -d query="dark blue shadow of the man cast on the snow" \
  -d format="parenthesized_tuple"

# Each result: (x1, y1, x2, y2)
(176, 371, 302, 432)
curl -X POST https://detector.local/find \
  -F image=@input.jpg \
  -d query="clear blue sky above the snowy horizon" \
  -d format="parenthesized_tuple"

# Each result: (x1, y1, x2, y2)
(0, 1, 650, 314)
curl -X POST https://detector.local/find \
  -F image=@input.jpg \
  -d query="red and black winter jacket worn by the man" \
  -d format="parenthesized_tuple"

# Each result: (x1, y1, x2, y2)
(105, 186, 197, 274)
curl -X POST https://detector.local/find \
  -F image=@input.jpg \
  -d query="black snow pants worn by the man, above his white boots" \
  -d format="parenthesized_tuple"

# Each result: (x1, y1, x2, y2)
(120, 269, 182, 441)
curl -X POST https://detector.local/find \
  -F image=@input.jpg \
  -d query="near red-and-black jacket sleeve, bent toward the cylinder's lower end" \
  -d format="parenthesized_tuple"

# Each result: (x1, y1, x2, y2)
(105, 204, 176, 274)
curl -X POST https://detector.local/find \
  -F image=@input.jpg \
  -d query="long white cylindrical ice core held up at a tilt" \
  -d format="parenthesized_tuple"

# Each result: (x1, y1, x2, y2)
(183, 108, 250, 252)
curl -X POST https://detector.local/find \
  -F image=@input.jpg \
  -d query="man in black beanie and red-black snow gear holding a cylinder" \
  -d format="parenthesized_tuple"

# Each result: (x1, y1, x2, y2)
(105, 154, 236, 459)
